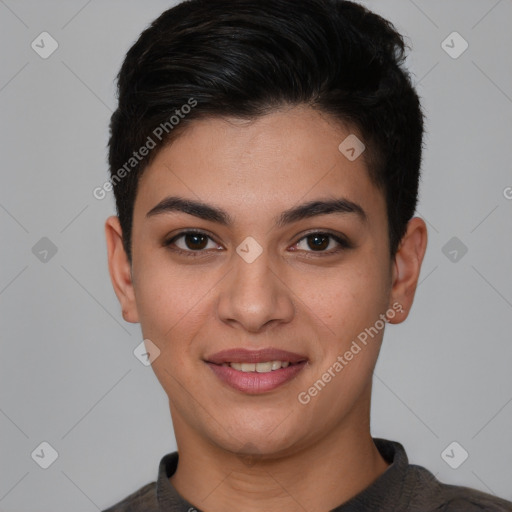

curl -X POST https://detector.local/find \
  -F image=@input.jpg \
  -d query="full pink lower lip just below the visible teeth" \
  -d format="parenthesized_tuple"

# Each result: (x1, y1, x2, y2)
(206, 361, 306, 395)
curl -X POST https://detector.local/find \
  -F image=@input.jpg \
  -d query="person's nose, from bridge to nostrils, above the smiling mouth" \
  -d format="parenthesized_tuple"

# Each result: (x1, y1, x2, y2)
(218, 250, 295, 333)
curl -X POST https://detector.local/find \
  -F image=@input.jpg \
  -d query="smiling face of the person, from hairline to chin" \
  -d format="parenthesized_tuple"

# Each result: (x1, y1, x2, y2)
(107, 107, 421, 455)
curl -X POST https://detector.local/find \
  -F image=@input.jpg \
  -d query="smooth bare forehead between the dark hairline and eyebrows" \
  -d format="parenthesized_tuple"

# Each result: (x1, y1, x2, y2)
(136, 107, 385, 224)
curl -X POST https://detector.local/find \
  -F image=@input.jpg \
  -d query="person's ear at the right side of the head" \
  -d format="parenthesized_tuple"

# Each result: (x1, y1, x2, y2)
(388, 217, 427, 324)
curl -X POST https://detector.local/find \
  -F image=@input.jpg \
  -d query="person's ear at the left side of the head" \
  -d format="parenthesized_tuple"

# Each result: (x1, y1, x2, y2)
(105, 216, 139, 323)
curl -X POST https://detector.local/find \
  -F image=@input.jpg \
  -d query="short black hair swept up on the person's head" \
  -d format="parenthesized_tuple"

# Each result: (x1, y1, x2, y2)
(109, 0, 424, 261)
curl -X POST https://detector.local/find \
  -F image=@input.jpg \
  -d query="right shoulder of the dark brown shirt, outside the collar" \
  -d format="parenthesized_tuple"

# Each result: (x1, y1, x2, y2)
(409, 465, 512, 512)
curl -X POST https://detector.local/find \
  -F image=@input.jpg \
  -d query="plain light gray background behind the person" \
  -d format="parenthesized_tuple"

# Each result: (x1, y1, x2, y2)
(0, 0, 512, 512)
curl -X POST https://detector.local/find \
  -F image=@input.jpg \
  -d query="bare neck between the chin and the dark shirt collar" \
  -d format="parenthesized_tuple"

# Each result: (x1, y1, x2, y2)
(170, 403, 388, 512)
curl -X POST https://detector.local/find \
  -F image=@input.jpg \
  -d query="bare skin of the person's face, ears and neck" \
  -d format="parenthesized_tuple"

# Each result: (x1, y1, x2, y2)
(105, 106, 427, 512)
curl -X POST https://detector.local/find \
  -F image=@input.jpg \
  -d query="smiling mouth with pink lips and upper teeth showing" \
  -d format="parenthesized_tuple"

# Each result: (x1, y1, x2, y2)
(205, 348, 308, 395)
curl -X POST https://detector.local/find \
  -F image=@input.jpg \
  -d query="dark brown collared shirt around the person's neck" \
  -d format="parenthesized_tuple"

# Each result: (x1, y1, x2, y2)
(103, 438, 512, 512)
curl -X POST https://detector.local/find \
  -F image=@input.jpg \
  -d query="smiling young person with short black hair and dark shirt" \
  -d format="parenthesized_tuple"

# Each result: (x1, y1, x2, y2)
(102, 0, 512, 512)
